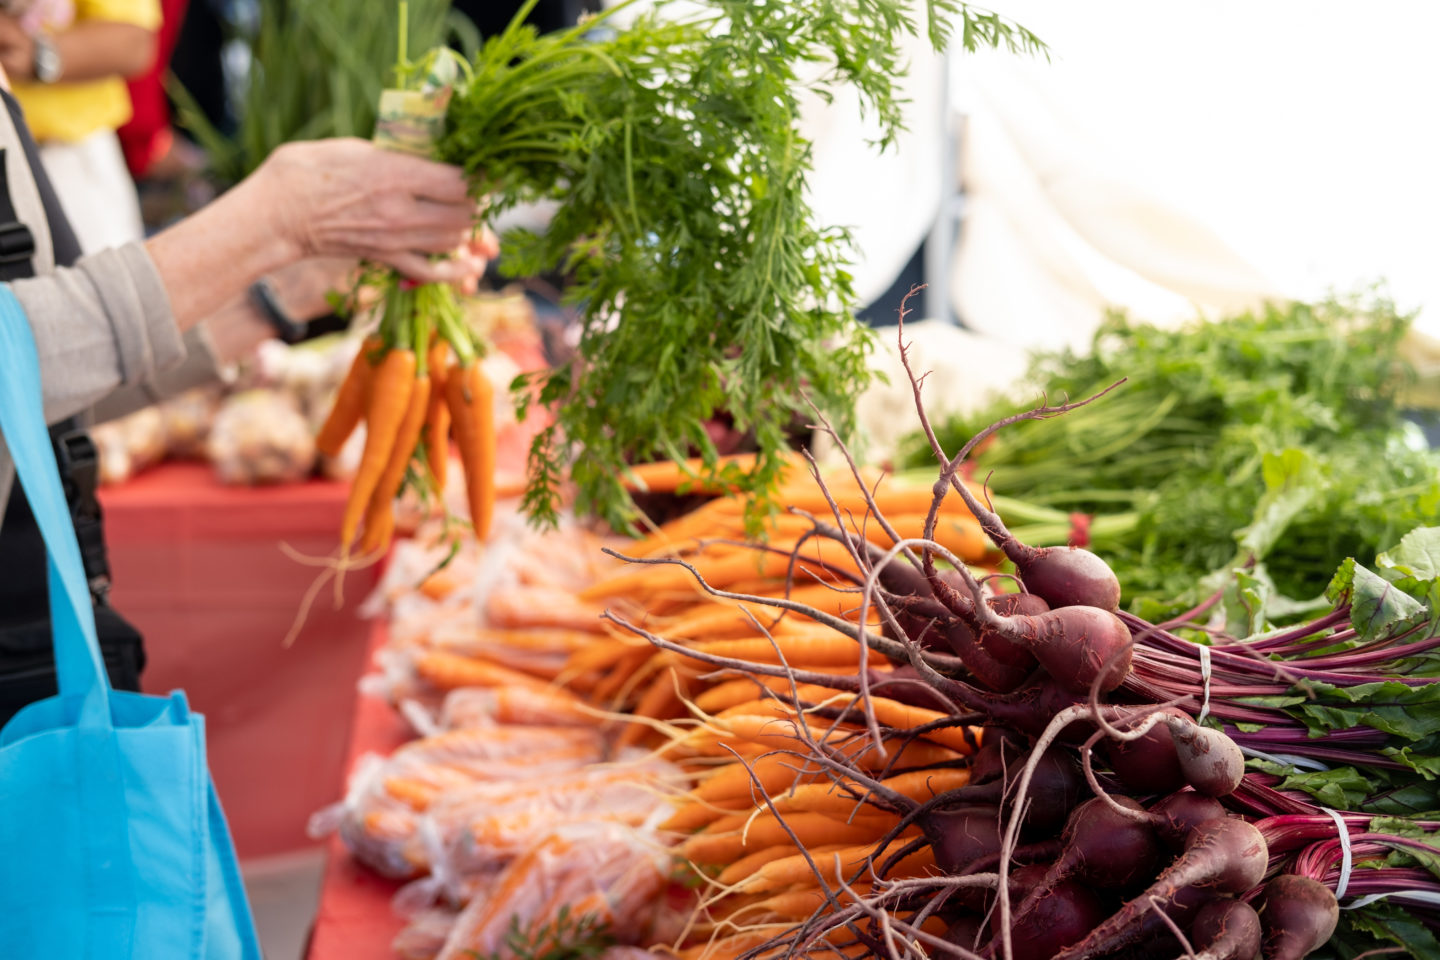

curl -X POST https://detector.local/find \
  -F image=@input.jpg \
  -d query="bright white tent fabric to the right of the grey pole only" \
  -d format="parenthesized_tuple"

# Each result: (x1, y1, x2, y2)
(953, 0, 1440, 345)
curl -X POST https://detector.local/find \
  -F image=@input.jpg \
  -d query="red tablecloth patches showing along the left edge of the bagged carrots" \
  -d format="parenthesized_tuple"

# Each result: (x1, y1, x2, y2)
(307, 623, 409, 960)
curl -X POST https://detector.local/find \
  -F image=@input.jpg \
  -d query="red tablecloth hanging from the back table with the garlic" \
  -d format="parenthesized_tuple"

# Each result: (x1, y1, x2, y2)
(101, 463, 377, 859)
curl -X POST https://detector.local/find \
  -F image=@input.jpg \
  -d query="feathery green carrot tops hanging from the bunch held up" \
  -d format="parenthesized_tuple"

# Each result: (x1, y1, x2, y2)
(439, 0, 1044, 528)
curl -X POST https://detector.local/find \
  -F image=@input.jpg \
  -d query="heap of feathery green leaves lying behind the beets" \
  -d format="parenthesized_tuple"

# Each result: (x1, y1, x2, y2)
(907, 295, 1440, 618)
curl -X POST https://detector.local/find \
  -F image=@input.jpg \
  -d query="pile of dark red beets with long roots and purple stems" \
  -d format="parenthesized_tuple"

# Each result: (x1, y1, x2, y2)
(616, 328, 1440, 960)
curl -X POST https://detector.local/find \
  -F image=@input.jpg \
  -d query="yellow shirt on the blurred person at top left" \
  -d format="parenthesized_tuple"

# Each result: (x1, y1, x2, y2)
(14, 0, 160, 142)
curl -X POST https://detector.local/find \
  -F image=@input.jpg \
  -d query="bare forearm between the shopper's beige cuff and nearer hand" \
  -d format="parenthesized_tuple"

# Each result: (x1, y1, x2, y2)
(145, 171, 300, 336)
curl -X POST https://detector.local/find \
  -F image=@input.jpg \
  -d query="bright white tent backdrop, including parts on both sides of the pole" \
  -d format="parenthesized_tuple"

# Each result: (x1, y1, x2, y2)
(806, 0, 1440, 457)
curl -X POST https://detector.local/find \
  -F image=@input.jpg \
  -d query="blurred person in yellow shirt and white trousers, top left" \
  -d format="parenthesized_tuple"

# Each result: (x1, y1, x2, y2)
(0, 0, 161, 253)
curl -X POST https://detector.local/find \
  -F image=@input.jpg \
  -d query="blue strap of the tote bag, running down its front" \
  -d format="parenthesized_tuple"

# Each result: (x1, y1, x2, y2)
(0, 285, 137, 956)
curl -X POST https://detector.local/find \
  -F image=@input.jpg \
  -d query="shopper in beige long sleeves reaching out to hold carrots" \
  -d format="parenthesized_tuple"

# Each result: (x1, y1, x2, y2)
(0, 39, 494, 723)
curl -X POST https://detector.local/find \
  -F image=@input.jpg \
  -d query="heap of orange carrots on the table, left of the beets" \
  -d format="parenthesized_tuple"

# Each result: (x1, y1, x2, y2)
(318, 463, 995, 960)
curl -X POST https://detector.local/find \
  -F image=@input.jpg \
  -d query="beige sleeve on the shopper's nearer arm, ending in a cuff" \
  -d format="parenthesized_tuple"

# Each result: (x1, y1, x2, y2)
(12, 243, 186, 423)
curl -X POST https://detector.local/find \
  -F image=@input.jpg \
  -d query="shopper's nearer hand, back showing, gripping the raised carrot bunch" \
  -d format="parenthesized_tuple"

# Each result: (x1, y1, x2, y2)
(264, 138, 494, 286)
